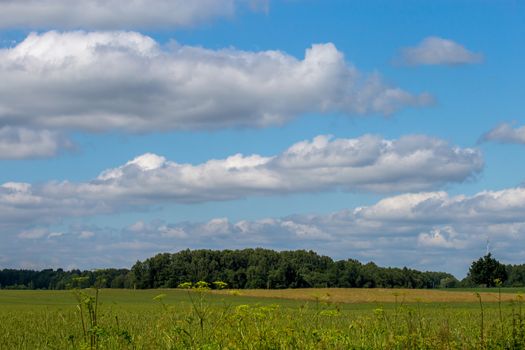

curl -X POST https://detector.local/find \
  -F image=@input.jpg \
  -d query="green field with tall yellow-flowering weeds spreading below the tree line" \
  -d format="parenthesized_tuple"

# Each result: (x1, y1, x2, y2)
(0, 289, 525, 349)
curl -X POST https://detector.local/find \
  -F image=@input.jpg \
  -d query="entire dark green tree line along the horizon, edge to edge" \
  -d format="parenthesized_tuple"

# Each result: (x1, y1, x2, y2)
(0, 248, 525, 289)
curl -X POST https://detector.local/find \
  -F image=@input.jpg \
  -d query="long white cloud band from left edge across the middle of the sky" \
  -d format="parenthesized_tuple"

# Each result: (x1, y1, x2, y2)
(0, 135, 483, 230)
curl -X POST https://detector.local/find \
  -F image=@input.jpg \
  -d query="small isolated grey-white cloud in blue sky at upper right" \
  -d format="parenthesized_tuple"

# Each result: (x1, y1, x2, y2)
(400, 36, 483, 66)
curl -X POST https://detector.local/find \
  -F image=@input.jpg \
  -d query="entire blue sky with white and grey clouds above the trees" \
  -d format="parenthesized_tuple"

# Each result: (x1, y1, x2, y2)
(0, 0, 525, 278)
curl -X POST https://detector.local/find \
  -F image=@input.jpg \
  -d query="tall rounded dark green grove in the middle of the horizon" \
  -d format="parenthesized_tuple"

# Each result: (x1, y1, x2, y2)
(131, 248, 457, 289)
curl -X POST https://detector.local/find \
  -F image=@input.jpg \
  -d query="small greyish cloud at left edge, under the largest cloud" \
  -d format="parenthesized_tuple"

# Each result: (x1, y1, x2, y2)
(0, 126, 72, 159)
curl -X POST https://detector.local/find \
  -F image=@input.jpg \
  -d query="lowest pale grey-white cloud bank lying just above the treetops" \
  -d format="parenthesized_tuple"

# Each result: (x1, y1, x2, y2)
(8, 187, 525, 277)
